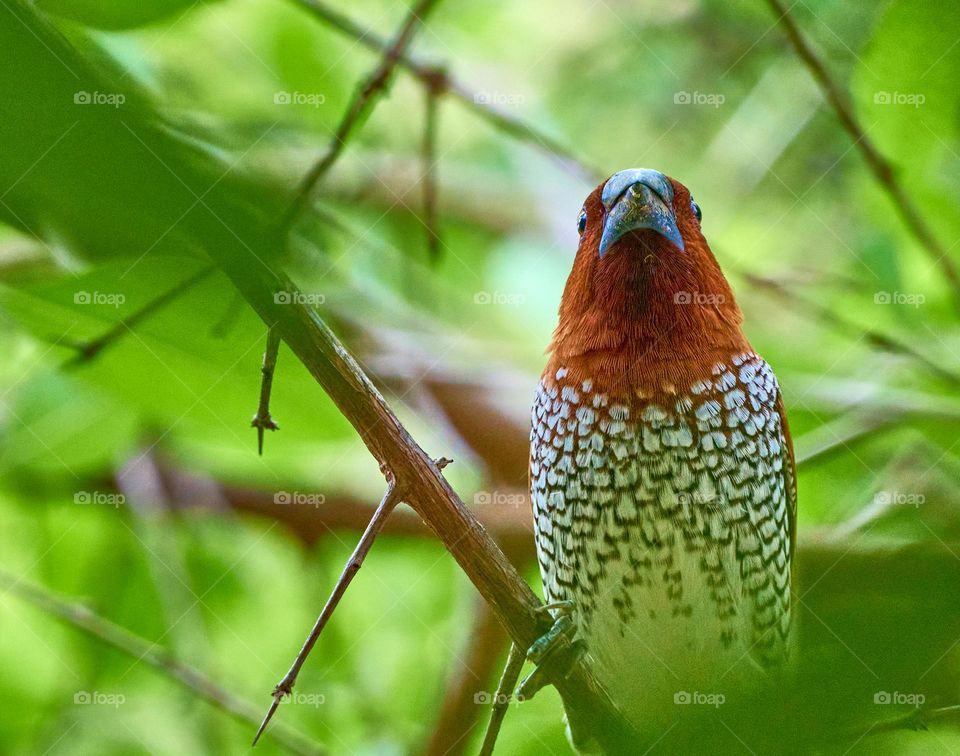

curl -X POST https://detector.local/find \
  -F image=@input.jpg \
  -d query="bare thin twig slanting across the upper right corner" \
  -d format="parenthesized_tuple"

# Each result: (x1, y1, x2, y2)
(767, 0, 960, 309)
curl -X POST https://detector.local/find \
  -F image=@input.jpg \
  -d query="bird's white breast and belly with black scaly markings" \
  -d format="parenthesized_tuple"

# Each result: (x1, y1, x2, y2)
(530, 353, 792, 728)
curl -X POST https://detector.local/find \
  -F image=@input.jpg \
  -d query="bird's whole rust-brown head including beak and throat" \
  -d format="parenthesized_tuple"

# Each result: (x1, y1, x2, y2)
(548, 168, 749, 391)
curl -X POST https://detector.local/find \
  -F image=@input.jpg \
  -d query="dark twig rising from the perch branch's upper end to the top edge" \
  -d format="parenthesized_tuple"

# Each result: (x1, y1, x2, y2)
(280, 0, 439, 237)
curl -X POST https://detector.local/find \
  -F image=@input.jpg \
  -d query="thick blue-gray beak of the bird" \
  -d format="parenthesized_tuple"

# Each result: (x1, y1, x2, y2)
(600, 168, 684, 257)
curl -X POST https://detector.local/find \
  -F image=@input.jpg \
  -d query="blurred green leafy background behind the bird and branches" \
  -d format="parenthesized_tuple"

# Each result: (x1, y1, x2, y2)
(0, 0, 960, 754)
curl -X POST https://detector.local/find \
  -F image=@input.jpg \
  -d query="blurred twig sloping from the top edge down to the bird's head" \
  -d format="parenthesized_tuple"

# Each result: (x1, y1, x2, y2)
(286, 0, 607, 181)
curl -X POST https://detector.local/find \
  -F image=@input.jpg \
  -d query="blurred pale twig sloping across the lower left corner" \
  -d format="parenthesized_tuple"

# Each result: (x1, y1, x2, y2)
(0, 571, 323, 756)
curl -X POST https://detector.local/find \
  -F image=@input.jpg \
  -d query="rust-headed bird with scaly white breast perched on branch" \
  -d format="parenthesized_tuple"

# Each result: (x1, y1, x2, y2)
(529, 168, 797, 742)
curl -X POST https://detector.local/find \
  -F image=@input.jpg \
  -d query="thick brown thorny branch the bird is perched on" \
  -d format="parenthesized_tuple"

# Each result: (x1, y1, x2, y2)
(207, 220, 636, 744)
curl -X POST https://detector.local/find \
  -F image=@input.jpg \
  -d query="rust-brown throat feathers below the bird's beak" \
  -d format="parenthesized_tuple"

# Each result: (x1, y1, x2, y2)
(544, 231, 751, 396)
